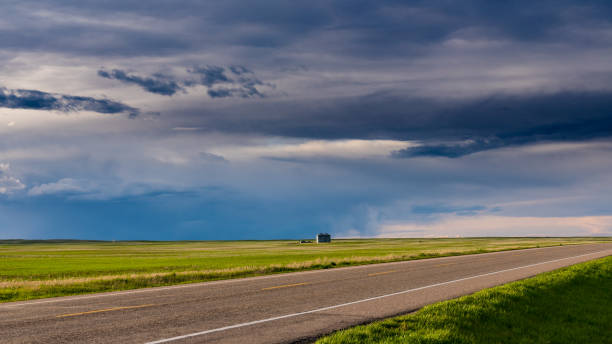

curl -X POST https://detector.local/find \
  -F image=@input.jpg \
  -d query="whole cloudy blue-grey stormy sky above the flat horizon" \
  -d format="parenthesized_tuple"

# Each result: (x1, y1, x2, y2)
(0, 0, 612, 240)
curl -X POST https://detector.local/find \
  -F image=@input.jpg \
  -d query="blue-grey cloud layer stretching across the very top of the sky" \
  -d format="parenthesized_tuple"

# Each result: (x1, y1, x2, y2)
(7, 0, 612, 58)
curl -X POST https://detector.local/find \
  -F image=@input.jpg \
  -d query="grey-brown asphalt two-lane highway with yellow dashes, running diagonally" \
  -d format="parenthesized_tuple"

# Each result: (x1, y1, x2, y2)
(0, 244, 612, 344)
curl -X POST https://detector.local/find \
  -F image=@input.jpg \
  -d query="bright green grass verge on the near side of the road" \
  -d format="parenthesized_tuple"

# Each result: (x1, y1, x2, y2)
(317, 257, 612, 344)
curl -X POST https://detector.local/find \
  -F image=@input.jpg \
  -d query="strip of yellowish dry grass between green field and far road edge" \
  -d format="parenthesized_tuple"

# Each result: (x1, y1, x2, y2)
(0, 245, 545, 303)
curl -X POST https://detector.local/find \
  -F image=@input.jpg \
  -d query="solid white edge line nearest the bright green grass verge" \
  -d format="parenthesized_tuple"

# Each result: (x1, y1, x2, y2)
(146, 250, 605, 344)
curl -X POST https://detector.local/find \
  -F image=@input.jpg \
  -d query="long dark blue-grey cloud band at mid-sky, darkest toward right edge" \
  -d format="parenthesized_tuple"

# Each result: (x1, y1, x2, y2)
(172, 92, 612, 158)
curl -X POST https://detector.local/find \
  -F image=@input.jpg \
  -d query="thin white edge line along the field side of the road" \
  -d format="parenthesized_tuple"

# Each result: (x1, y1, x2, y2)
(0, 244, 600, 309)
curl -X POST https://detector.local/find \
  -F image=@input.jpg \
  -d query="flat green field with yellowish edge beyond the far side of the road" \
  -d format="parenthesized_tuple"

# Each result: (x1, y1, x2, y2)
(0, 238, 612, 302)
